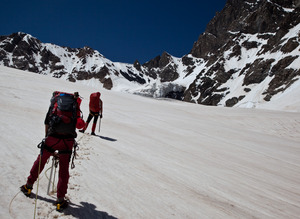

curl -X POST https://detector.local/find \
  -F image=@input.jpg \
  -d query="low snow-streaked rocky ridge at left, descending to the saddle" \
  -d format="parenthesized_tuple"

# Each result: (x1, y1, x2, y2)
(0, 33, 142, 90)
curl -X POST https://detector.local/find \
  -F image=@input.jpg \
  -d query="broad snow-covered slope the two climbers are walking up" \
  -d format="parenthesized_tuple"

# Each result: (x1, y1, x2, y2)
(0, 66, 300, 219)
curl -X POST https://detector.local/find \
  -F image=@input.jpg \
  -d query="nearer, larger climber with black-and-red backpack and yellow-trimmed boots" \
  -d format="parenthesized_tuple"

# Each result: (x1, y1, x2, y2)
(20, 91, 85, 211)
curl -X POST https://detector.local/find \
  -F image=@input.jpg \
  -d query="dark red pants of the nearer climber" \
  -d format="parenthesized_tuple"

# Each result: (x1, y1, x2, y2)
(27, 136, 74, 198)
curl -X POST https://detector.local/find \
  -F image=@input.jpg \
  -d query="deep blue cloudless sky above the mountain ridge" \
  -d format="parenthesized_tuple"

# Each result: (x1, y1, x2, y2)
(0, 0, 226, 64)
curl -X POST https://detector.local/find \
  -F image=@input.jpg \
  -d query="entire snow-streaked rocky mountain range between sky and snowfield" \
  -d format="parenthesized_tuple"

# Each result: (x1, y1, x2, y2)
(0, 0, 300, 107)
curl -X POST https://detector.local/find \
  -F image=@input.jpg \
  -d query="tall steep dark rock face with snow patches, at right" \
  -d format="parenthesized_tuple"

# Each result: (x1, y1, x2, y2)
(184, 0, 300, 106)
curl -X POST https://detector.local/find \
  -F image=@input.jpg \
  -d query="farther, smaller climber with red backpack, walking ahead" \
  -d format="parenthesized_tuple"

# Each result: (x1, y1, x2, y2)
(79, 92, 103, 135)
